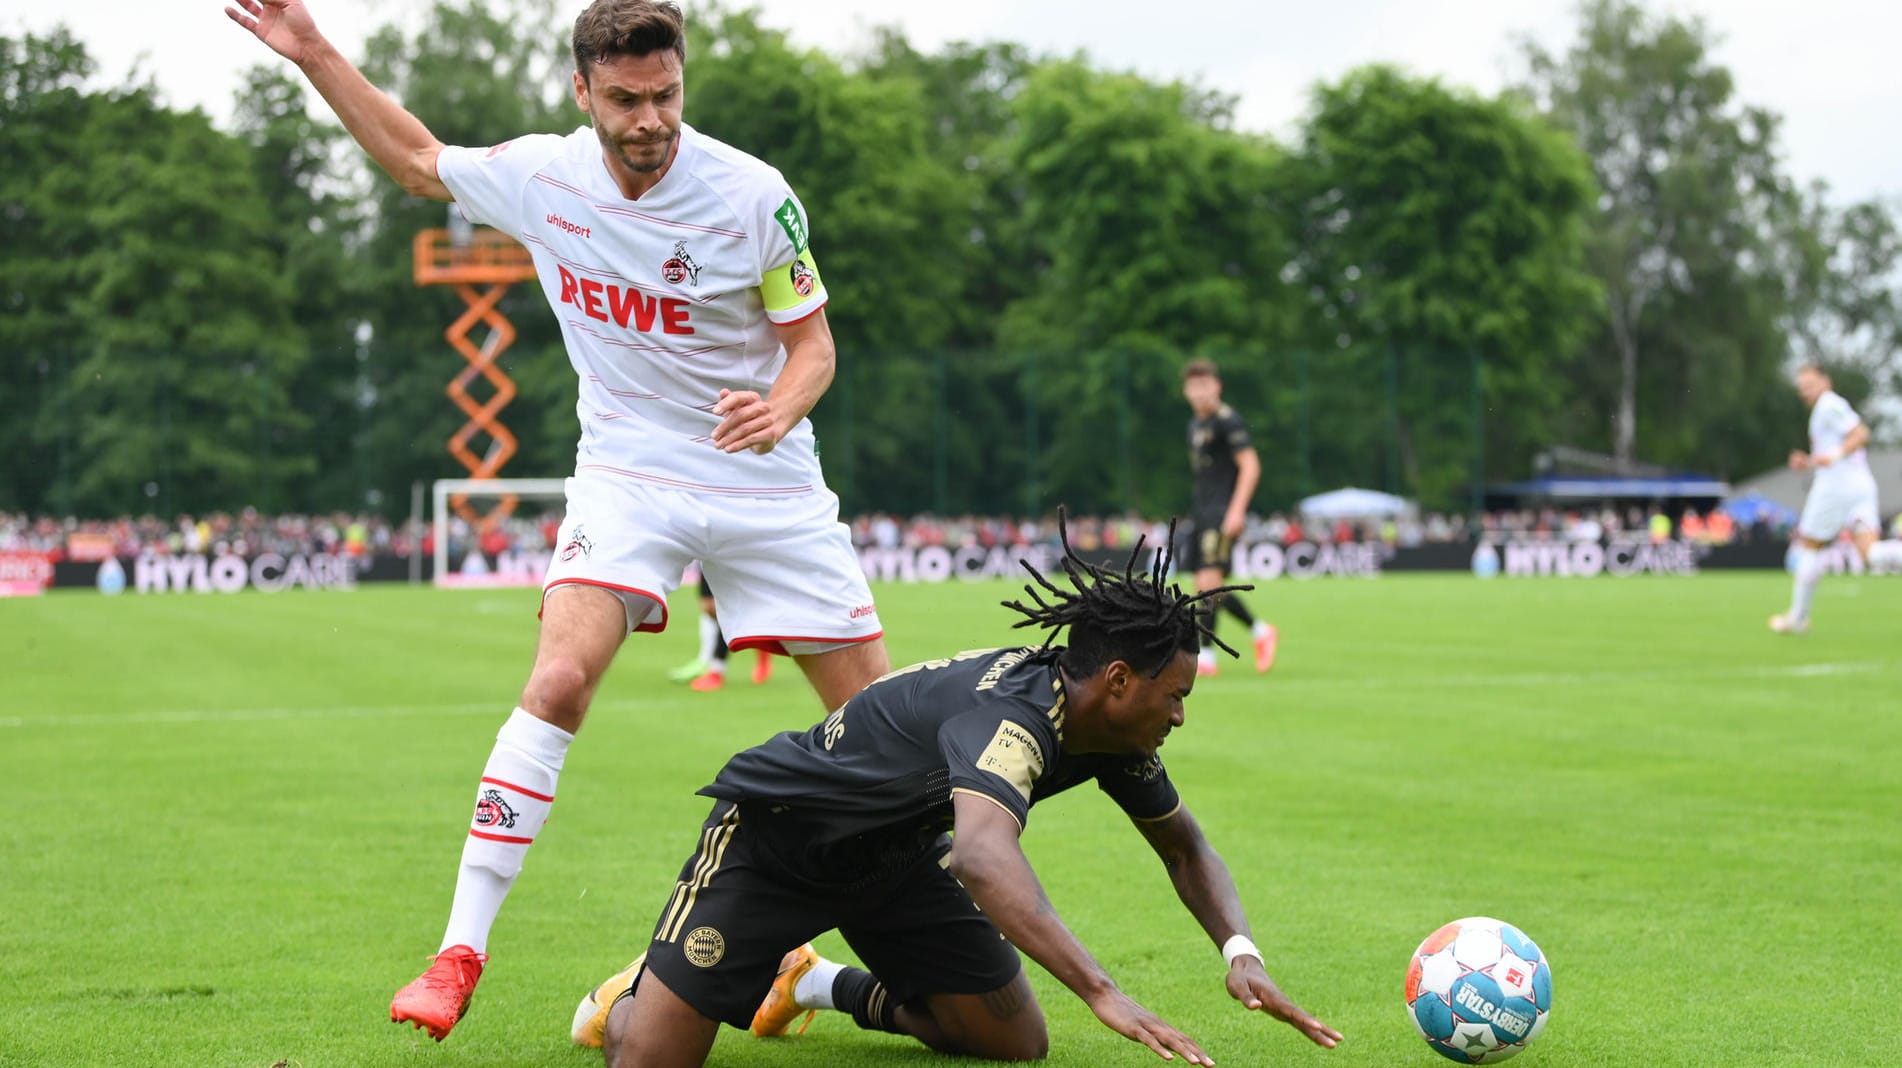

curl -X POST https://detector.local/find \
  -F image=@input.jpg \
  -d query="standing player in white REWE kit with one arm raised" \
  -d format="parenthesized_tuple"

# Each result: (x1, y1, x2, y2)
(226, 0, 890, 1039)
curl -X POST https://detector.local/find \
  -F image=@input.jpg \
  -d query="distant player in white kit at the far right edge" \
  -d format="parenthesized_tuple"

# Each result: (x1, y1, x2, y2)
(1771, 363, 1902, 635)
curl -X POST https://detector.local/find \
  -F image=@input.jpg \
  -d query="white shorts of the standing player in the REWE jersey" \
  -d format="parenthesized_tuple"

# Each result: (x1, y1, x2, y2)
(542, 473, 884, 654)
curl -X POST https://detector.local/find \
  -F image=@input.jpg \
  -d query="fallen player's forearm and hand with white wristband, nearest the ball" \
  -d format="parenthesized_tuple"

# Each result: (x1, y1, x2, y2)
(1135, 806, 1341, 1049)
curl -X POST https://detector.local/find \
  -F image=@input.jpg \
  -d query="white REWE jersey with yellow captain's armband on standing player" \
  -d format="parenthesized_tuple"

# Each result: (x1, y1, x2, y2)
(436, 124, 840, 496)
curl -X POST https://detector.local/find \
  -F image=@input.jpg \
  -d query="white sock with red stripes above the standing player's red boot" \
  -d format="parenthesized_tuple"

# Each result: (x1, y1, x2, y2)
(443, 709, 574, 952)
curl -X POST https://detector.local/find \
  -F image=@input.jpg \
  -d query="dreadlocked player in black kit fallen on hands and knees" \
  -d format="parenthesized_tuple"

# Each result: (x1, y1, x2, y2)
(573, 520, 1341, 1068)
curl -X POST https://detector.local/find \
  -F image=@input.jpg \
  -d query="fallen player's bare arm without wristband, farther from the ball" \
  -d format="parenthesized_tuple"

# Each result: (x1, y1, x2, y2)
(949, 791, 1215, 1064)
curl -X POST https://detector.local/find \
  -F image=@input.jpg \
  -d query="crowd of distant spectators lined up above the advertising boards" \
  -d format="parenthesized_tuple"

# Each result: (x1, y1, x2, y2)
(0, 505, 1788, 559)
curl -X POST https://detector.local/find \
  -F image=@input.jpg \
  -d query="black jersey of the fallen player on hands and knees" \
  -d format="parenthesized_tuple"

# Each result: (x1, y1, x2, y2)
(700, 648, 1177, 870)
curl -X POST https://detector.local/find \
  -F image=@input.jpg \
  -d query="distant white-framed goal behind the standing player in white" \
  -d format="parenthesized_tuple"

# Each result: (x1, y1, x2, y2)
(430, 479, 567, 587)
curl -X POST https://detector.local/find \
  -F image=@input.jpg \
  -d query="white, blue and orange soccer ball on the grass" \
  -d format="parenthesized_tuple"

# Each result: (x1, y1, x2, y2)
(1407, 916, 1552, 1064)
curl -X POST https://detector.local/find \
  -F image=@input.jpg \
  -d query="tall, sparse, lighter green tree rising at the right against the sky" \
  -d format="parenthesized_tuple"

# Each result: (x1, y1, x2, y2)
(1527, 0, 1873, 475)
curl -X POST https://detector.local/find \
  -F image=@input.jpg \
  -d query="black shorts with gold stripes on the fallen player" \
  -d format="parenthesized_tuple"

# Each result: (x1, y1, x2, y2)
(647, 800, 1023, 1028)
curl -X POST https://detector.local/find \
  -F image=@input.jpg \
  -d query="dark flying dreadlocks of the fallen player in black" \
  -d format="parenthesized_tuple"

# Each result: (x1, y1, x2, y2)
(1002, 507, 1253, 678)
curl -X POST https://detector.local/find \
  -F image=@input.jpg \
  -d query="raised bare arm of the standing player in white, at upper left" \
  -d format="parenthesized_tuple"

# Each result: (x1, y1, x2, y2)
(224, 0, 455, 200)
